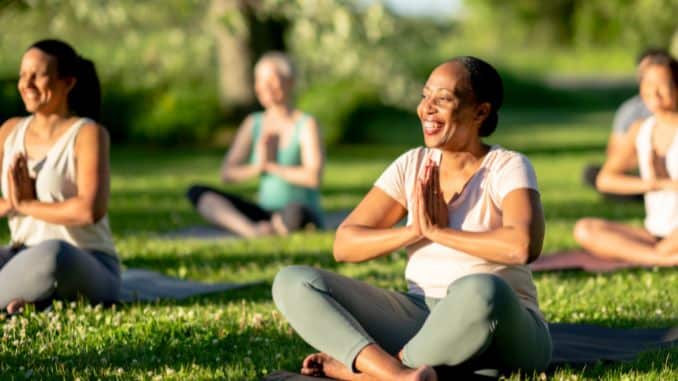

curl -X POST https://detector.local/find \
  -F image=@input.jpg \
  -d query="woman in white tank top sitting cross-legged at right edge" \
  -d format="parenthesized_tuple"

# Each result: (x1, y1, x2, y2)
(574, 53, 678, 266)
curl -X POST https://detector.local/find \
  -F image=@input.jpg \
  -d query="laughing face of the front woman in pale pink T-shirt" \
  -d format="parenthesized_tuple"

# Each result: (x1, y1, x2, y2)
(417, 62, 483, 149)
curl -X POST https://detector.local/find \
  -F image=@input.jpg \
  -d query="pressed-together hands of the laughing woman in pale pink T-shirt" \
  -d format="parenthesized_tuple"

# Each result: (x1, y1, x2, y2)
(411, 158, 448, 240)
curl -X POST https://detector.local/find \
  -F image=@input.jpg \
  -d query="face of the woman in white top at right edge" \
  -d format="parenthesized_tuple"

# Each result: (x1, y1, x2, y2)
(640, 64, 678, 113)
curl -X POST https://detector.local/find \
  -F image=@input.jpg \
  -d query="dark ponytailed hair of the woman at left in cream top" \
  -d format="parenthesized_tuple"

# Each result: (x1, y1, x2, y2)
(29, 40, 101, 120)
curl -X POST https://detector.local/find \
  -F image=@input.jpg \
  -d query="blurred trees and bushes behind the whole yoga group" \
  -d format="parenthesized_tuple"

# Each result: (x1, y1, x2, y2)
(0, 0, 678, 147)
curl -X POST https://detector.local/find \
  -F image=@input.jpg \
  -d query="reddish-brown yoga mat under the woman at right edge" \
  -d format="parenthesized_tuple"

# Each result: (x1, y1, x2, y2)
(529, 251, 651, 273)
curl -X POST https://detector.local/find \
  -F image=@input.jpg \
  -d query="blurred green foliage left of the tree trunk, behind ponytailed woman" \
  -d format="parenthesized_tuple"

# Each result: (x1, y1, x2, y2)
(0, 0, 219, 143)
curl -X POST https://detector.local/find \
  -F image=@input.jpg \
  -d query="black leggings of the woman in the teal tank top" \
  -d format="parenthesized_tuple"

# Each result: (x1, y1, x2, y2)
(186, 185, 323, 231)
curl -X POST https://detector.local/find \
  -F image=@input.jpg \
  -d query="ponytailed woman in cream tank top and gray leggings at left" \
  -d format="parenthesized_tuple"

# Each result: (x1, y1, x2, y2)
(0, 40, 120, 313)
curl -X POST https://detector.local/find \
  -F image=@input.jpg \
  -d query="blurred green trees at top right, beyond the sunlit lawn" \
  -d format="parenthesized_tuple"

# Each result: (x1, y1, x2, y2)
(465, 0, 678, 51)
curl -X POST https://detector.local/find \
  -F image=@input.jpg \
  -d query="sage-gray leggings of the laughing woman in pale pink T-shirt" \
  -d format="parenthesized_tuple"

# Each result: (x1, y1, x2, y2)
(273, 266, 551, 371)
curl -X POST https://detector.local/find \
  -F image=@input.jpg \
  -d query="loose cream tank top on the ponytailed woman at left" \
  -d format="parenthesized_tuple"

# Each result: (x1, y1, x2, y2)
(0, 116, 116, 256)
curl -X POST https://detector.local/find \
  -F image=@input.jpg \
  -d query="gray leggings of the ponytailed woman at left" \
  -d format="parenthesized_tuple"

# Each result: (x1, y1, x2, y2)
(0, 240, 120, 308)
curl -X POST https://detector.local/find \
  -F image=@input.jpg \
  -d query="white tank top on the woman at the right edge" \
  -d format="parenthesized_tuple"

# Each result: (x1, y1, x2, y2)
(636, 116, 678, 237)
